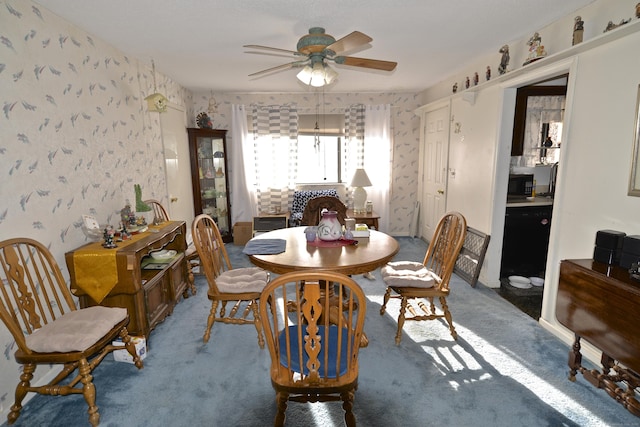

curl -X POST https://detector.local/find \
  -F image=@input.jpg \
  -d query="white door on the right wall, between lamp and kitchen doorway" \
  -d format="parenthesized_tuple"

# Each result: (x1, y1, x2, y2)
(420, 105, 449, 241)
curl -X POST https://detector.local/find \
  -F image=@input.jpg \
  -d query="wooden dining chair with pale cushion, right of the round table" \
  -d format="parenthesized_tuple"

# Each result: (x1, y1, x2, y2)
(380, 212, 467, 345)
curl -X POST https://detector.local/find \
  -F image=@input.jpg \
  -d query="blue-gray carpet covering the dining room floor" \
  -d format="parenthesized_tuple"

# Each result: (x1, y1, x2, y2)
(5, 238, 640, 427)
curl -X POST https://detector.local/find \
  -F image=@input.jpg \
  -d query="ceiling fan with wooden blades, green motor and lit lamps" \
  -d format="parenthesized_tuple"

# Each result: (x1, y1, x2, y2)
(243, 27, 398, 87)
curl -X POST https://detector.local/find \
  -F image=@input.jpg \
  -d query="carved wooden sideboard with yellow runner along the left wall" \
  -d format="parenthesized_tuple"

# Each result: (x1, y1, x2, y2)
(65, 221, 188, 339)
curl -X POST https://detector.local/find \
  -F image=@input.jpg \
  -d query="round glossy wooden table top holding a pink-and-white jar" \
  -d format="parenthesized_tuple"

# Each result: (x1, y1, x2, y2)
(249, 227, 399, 275)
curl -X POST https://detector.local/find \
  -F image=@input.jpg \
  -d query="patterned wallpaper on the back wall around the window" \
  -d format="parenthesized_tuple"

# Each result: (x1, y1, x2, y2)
(188, 92, 421, 236)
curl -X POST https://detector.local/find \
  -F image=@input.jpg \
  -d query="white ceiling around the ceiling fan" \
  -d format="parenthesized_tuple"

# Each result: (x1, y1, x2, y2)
(36, 0, 594, 92)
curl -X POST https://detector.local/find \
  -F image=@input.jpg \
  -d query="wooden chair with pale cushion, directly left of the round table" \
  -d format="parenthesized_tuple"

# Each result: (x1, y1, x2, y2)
(193, 214, 269, 348)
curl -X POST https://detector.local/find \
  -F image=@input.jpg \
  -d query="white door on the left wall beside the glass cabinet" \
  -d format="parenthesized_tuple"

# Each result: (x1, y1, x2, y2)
(160, 105, 195, 237)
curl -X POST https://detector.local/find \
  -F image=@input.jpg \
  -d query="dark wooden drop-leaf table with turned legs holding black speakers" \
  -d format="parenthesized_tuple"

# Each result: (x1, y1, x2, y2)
(556, 259, 640, 416)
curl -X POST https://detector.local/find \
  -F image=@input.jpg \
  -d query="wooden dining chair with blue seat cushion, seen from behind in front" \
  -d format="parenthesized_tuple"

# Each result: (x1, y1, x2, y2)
(260, 270, 366, 426)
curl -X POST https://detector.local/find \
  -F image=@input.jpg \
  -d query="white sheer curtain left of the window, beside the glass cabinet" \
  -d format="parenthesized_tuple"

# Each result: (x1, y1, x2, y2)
(229, 105, 258, 225)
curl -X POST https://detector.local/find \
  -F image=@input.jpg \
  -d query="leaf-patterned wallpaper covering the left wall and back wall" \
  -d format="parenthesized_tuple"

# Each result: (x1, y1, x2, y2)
(0, 0, 420, 419)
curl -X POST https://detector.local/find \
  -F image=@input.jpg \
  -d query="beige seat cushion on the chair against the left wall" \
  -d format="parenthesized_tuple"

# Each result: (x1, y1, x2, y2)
(26, 306, 127, 353)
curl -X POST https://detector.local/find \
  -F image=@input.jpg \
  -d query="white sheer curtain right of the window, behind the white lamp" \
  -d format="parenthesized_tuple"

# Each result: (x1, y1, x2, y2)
(364, 104, 393, 232)
